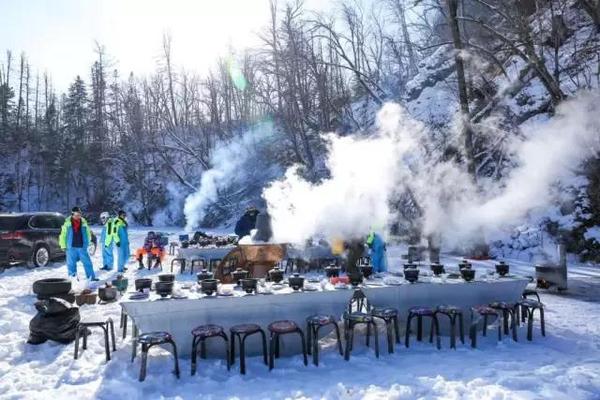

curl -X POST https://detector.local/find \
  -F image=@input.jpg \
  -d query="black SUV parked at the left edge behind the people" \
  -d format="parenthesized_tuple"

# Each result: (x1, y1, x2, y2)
(0, 212, 97, 268)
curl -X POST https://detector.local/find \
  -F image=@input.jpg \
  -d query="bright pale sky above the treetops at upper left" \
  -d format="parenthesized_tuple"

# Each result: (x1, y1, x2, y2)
(0, 0, 333, 90)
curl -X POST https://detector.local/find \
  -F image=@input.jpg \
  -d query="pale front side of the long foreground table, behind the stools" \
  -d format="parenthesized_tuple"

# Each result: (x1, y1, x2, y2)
(121, 277, 529, 357)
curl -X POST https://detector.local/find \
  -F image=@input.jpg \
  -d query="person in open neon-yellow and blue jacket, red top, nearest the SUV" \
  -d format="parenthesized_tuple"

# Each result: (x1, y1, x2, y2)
(58, 207, 98, 281)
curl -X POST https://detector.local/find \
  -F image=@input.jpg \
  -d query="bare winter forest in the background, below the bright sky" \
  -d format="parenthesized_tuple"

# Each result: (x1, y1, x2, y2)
(0, 0, 600, 224)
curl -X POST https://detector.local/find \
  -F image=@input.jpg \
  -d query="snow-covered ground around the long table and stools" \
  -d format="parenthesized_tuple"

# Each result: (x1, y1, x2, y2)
(0, 230, 600, 400)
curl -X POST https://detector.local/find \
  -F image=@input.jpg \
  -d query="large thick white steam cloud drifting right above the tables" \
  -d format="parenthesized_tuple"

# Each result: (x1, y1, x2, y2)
(263, 93, 600, 245)
